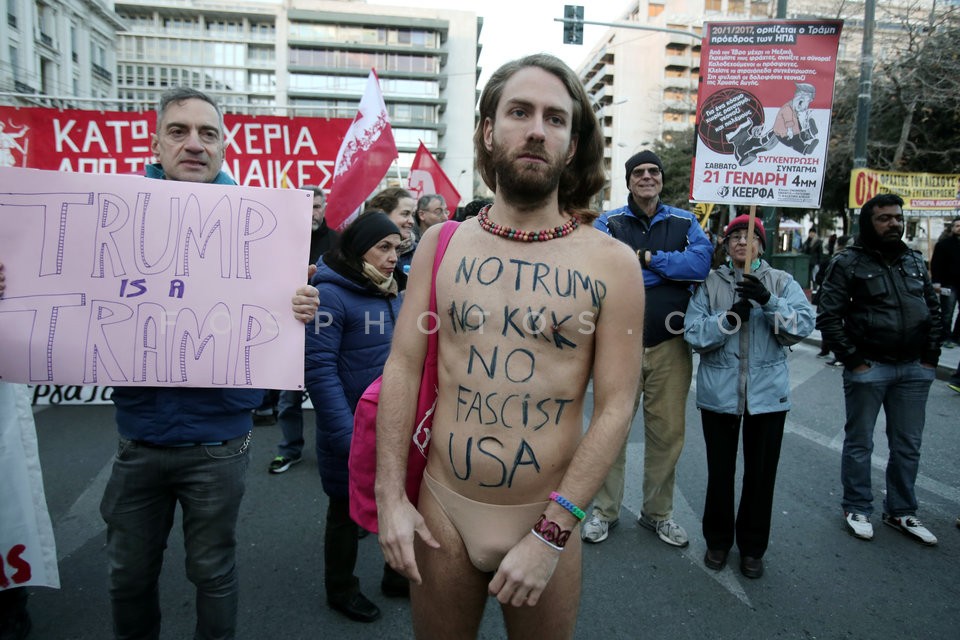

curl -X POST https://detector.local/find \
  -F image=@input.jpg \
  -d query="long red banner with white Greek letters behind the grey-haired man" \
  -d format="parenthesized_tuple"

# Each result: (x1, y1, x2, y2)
(0, 107, 352, 189)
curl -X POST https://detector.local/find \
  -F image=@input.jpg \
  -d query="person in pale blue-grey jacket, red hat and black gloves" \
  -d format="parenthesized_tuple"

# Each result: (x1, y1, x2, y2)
(684, 215, 815, 578)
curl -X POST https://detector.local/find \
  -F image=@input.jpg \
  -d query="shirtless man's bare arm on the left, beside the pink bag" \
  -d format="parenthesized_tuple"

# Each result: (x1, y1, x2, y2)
(376, 225, 440, 584)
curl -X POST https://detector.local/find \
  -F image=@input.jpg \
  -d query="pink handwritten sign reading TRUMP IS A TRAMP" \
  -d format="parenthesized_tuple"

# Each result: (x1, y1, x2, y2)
(0, 168, 313, 393)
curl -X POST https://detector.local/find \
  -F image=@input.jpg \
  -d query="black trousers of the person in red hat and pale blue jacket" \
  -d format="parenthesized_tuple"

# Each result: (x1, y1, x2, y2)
(700, 409, 787, 558)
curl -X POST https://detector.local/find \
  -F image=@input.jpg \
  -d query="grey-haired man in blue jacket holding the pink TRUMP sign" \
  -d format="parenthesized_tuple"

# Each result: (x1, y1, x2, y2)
(100, 88, 318, 640)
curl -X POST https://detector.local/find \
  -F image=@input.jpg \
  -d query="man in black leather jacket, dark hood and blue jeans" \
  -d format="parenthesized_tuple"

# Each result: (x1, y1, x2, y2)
(817, 194, 941, 545)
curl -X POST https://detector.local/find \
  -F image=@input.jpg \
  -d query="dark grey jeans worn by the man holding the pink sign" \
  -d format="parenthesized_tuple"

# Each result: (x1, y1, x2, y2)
(100, 434, 250, 640)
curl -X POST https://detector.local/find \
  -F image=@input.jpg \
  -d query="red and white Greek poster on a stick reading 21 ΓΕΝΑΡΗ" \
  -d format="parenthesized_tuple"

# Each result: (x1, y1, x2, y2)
(690, 20, 843, 208)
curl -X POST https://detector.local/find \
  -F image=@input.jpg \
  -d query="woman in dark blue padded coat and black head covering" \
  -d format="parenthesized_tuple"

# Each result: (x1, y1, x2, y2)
(305, 211, 409, 622)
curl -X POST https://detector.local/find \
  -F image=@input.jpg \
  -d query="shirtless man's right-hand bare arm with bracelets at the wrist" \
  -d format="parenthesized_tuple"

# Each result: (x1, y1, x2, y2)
(490, 242, 644, 606)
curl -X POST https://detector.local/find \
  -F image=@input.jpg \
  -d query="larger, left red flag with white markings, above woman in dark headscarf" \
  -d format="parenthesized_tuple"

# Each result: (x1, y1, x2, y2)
(326, 69, 397, 229)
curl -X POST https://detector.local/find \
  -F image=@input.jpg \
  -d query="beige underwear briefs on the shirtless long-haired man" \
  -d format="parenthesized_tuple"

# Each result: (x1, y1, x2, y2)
(423, 471, 549, 572)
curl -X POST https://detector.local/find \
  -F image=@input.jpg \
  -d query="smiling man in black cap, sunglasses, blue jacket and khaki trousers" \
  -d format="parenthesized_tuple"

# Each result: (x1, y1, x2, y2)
(581, 151, 713, 547)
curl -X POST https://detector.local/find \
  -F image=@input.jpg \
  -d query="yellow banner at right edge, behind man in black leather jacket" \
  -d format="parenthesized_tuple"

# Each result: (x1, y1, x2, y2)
(849, 169, 960, 211)
